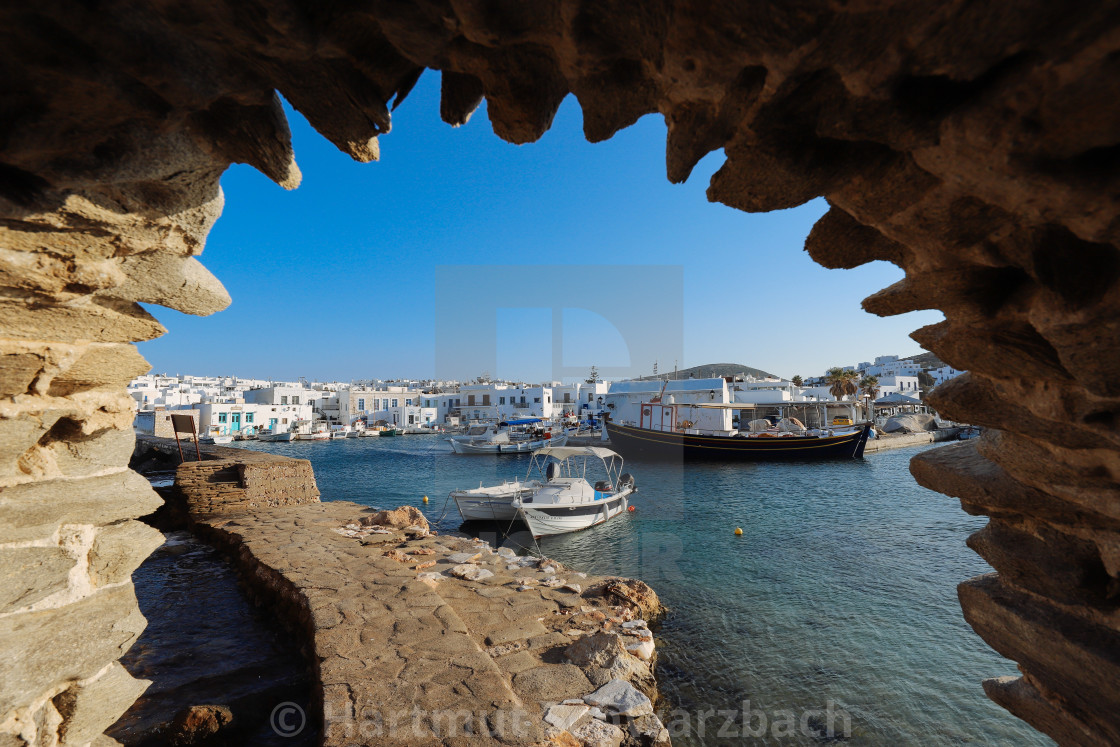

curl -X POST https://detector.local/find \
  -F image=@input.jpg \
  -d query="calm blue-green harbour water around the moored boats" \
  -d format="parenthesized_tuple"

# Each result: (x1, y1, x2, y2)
(234, 436, 1052, 745)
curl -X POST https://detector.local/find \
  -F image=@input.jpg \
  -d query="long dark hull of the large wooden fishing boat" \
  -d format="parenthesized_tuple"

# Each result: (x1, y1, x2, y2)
(606, 420, 871, 461)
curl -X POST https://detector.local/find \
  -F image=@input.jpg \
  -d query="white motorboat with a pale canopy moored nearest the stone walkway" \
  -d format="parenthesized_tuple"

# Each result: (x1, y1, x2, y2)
(511, 446, 636, 538)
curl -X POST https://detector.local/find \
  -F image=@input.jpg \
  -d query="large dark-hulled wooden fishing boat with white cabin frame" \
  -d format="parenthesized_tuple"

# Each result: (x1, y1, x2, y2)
(606, 398, 871, 461)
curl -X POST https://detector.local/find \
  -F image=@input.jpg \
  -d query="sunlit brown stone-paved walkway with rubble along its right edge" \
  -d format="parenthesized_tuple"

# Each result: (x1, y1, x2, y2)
(196, 502, 669, 747)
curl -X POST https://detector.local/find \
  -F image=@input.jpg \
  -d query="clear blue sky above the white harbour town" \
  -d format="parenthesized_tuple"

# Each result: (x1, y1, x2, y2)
(140, 71, 941, 381)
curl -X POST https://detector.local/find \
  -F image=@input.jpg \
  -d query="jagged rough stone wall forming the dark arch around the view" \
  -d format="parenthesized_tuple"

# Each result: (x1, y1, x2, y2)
(0, 0, 1120, 744)
